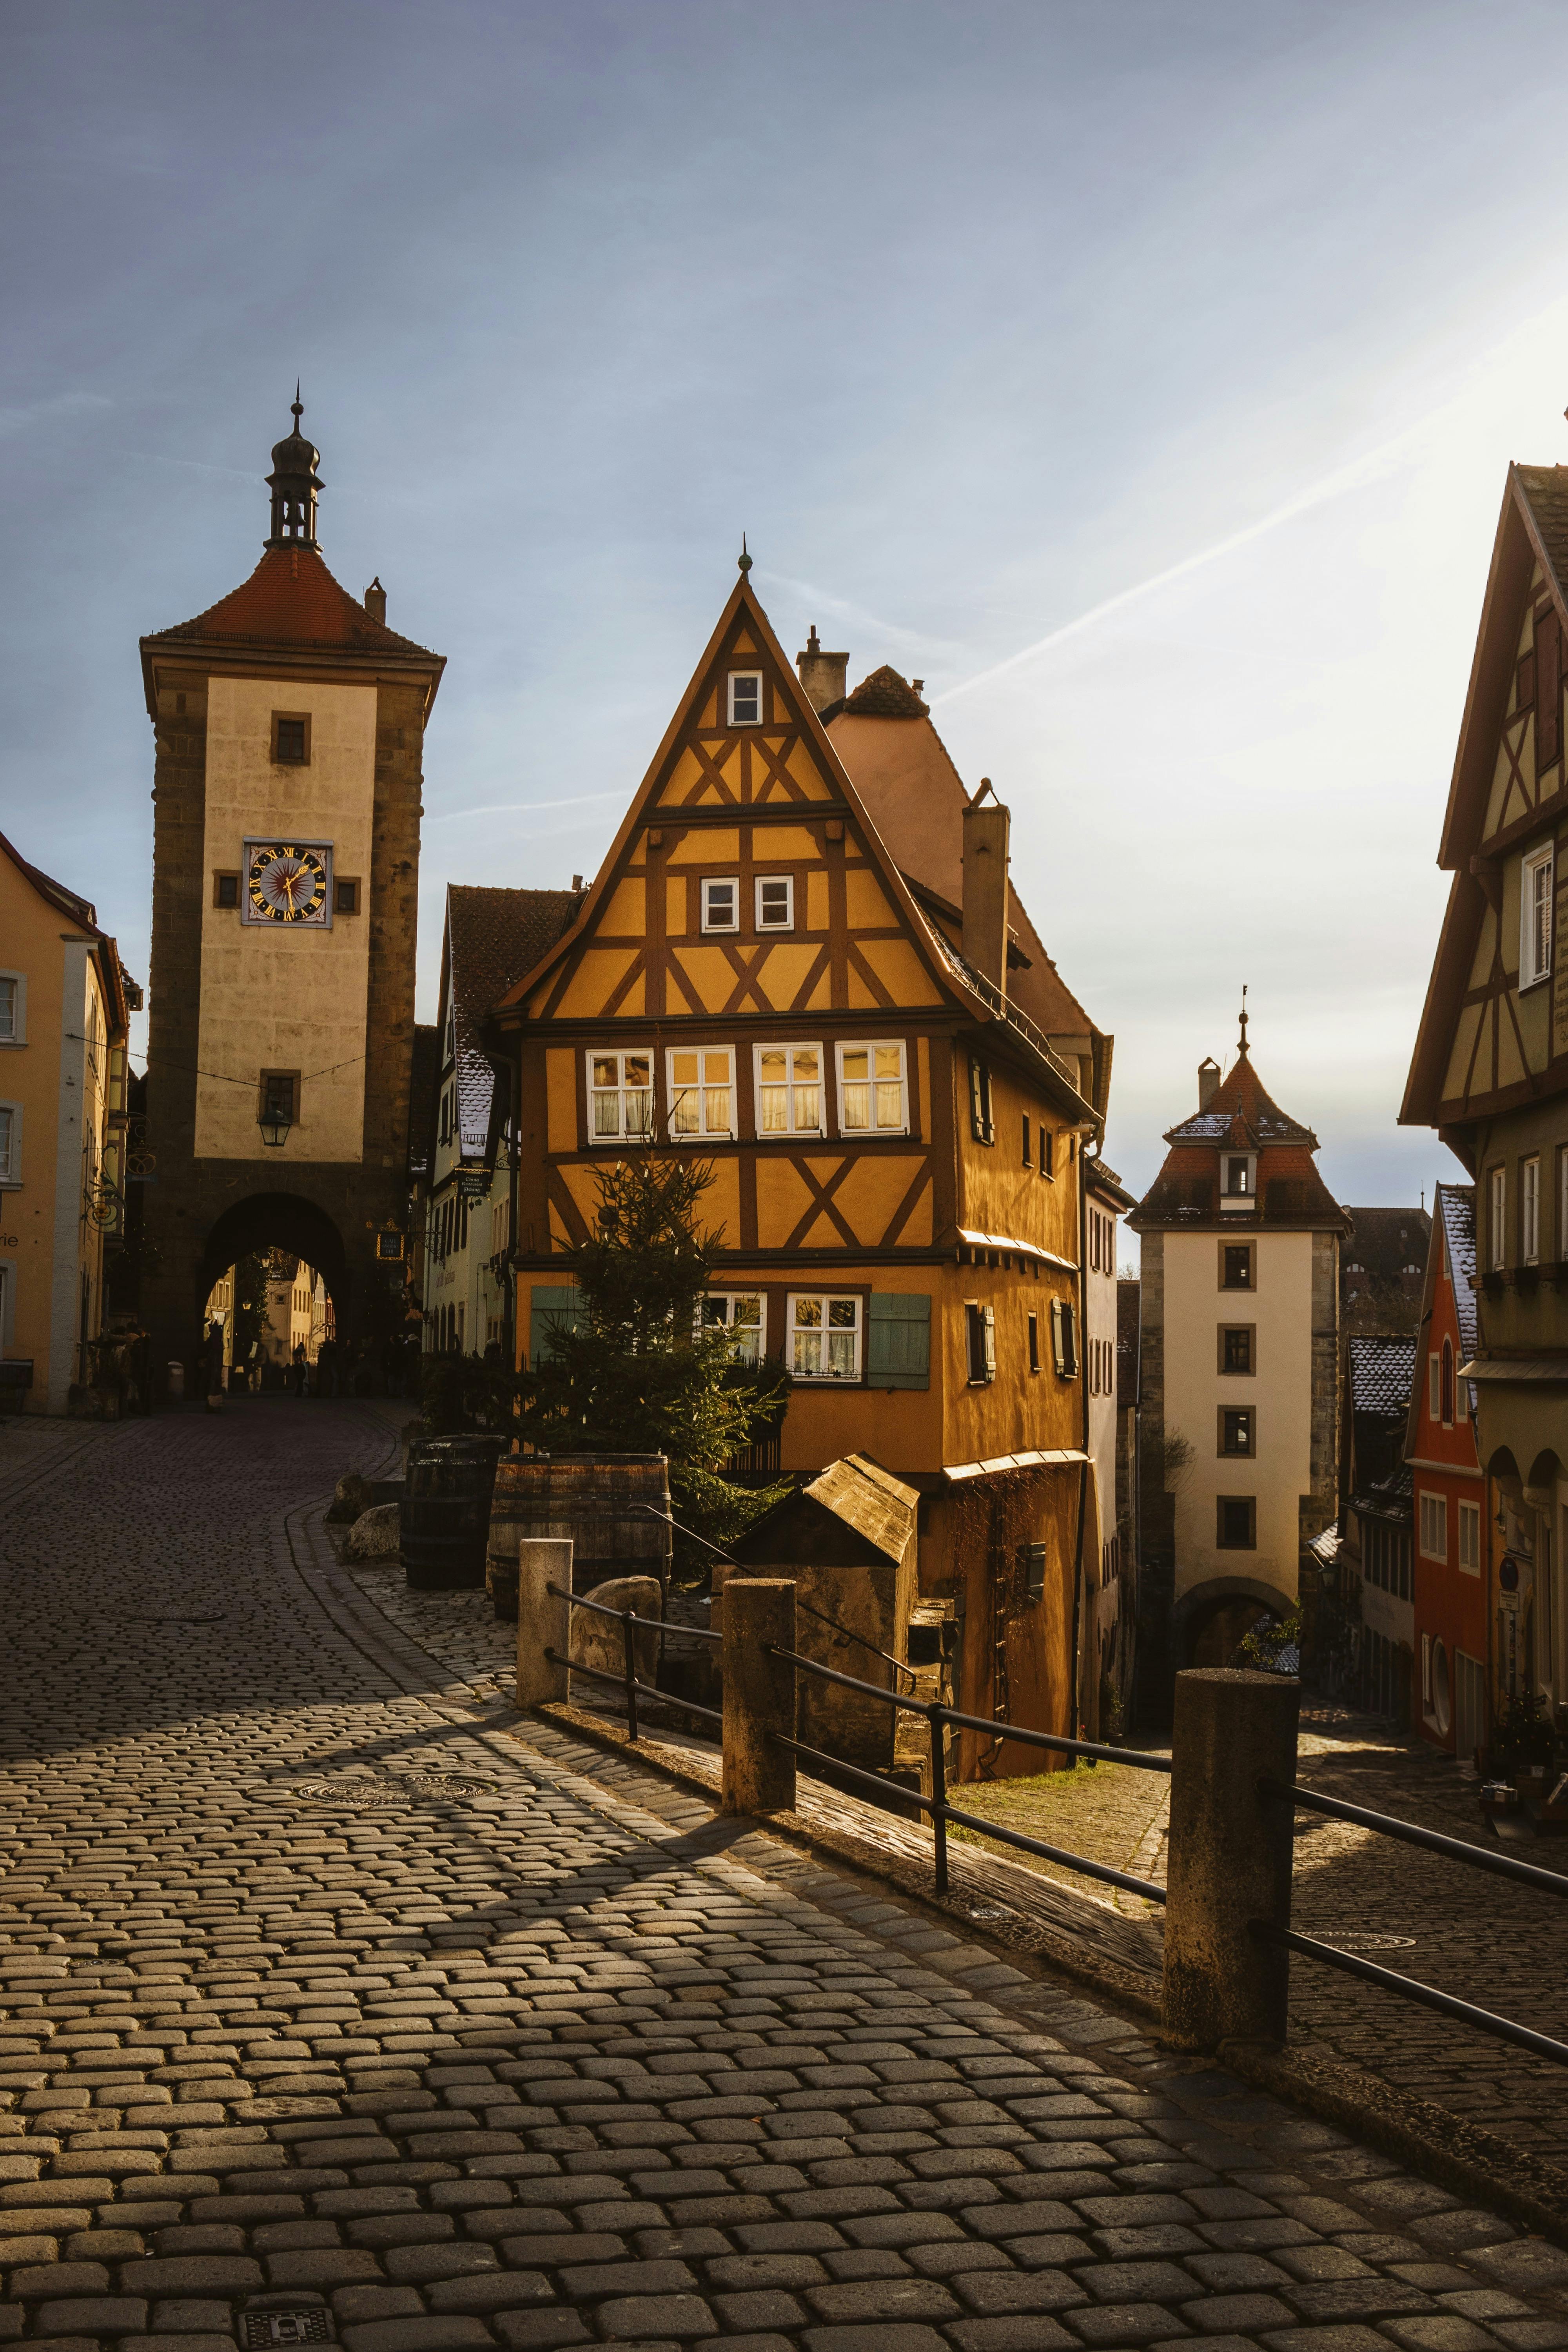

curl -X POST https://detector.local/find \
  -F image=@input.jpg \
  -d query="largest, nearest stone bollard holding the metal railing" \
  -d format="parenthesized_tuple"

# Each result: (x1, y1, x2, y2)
(1161, 1668, 1300, 2051)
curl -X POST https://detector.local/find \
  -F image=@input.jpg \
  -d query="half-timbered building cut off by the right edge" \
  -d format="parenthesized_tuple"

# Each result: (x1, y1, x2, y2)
(1399, 466, 1568, 1710)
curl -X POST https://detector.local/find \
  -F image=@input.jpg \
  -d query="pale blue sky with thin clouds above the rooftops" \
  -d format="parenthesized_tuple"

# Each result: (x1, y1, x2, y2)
(0, 0, 1568, 1242)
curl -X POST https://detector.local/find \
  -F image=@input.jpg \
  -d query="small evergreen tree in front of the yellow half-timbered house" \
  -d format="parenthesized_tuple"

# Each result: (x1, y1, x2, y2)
(519, 1152, 790, 1566)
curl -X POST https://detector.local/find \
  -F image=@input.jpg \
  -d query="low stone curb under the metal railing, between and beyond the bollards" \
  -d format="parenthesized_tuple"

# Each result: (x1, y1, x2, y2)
(524, 1700, 1568, 2249)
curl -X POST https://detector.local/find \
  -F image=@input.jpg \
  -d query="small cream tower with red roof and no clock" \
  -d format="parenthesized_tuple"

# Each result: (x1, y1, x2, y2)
(1129, 990, 1349, 1668)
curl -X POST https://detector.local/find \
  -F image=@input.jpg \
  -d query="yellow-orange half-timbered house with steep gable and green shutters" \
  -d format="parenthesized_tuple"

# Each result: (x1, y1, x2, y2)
(494, 576, 1114, 1769)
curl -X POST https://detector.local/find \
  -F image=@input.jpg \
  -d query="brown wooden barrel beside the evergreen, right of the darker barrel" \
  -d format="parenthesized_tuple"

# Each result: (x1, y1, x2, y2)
(484, 1454, 672, 1618)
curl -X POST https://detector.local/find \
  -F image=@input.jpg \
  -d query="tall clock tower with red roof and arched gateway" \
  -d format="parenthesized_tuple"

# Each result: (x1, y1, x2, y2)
(141, 395, 444, 1381)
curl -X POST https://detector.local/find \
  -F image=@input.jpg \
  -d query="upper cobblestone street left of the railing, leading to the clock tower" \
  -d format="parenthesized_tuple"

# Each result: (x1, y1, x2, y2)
(0, 1399, 1568, 2352)
